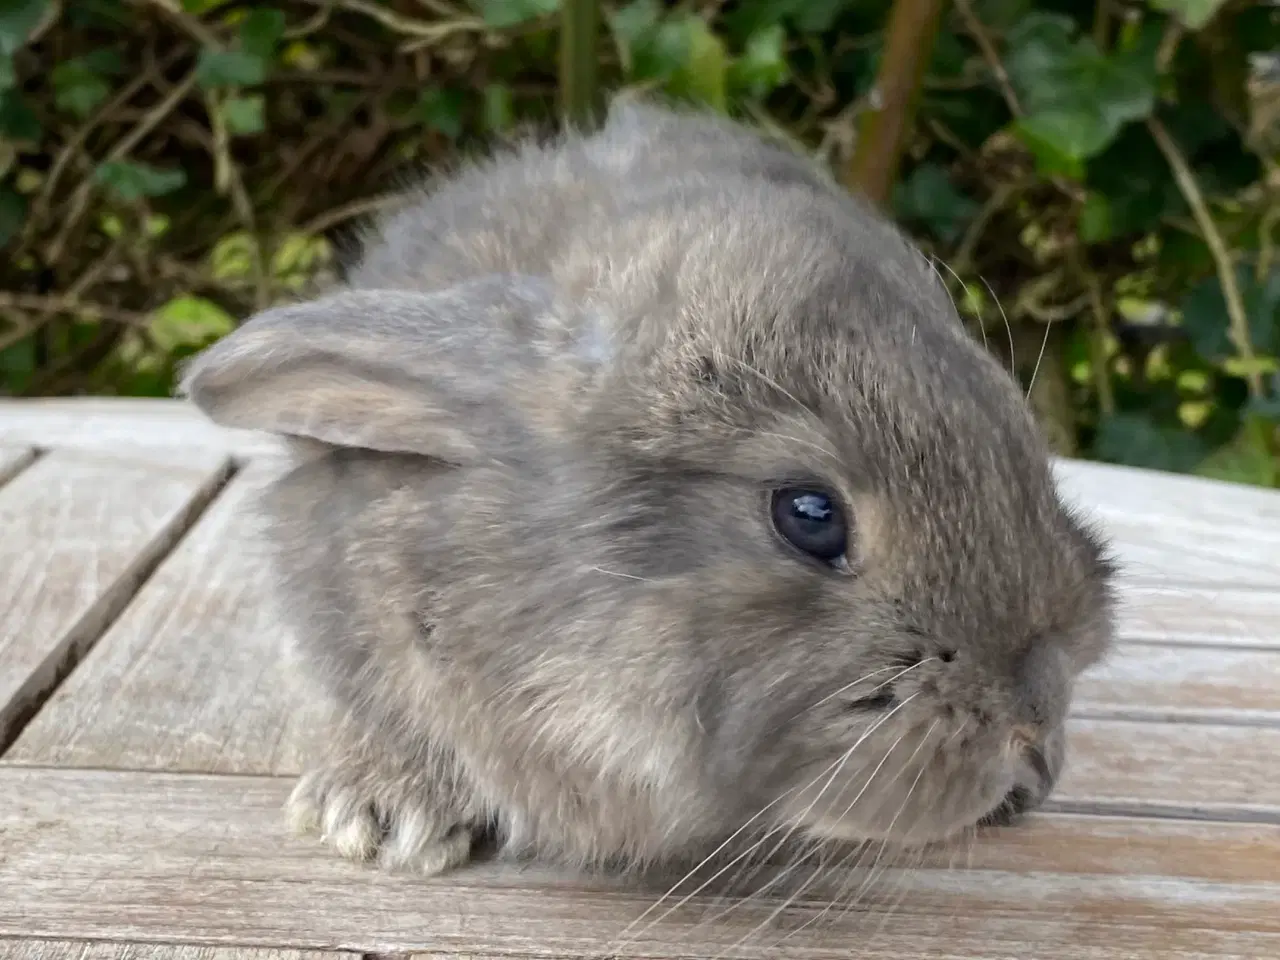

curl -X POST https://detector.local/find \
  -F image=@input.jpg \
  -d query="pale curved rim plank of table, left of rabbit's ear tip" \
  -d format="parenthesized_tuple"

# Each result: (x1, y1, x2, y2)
(0, 397, 282, 460)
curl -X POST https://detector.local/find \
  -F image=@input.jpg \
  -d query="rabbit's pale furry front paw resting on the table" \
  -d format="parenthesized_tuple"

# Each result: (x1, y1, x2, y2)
(285, 762, 480, 876)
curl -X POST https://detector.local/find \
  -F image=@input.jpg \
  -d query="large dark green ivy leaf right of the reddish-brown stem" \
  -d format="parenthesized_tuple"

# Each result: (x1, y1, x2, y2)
(1005, 14, 1157, 177)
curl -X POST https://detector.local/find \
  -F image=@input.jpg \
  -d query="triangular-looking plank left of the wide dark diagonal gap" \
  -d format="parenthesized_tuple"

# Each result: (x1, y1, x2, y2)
(0, 451, 229, 748)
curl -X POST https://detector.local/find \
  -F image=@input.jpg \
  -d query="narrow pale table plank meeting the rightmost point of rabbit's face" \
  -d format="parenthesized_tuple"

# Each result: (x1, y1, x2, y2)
(1119, 585, 1280, 650)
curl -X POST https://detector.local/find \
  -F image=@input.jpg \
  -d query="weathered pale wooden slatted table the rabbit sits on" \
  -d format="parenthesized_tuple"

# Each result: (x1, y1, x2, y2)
(0, 401, 1280, 960)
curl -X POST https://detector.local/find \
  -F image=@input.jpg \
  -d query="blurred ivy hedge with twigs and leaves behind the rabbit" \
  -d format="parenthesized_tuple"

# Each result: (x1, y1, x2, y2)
(0, 0, 1280, 486)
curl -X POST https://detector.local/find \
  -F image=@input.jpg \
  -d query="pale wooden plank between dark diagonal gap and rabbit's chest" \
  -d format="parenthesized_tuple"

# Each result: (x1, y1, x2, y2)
(5, 461, 321, 773)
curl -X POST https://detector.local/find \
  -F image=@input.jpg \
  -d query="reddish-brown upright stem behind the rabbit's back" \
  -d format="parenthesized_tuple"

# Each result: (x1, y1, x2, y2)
(845, 0, 945, 207)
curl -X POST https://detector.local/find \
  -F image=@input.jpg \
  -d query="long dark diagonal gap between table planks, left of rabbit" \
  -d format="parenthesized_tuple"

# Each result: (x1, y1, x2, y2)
(0, 460, 239, 756)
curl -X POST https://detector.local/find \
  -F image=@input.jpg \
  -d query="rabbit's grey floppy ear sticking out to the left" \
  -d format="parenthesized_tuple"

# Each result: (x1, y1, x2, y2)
(179, 276, 550, 463)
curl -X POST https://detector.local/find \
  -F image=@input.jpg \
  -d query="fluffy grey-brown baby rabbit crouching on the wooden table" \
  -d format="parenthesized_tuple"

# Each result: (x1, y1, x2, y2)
(179, 99, 1116, 874)
